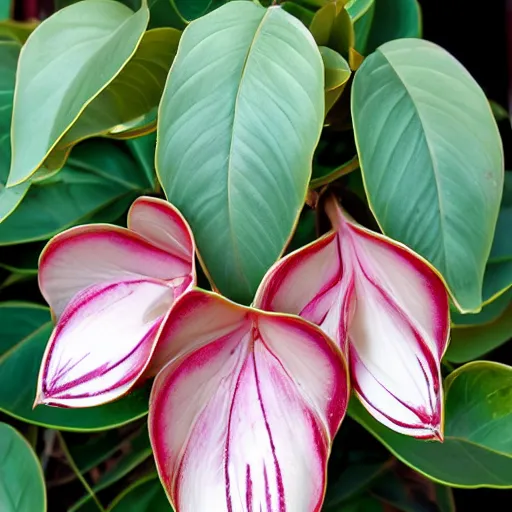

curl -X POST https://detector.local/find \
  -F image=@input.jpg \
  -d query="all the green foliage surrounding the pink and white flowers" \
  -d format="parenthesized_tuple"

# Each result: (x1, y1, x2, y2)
(0, 0, 512, 512)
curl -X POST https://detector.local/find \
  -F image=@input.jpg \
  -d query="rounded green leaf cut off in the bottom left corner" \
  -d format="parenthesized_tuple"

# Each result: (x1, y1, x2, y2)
(0, 423, 46, 512)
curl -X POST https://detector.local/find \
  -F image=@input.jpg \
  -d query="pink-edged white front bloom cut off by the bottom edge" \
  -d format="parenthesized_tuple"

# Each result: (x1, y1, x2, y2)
(149, 292, 348, 512)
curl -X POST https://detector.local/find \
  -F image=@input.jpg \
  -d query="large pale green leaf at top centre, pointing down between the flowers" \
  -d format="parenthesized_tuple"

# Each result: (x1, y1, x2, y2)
(156, 1, 324, 303)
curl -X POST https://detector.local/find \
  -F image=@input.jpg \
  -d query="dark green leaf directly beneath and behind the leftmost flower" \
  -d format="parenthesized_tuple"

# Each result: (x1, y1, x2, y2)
(0, 302, 149, 431)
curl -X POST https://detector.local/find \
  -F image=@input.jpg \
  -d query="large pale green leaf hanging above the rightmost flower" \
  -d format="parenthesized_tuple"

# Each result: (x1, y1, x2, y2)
(352, 39, 503, 312)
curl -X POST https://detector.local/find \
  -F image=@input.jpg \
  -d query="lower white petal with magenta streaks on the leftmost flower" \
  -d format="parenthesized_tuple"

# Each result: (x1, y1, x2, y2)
(36, 280, 174, 407)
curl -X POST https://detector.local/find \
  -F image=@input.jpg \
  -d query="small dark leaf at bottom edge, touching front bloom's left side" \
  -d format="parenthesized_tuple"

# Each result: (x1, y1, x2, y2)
(108, 474, 173, 512)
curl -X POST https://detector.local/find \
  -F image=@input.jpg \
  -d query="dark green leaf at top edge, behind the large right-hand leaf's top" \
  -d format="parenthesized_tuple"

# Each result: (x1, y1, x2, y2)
(364, 0, 422, 55)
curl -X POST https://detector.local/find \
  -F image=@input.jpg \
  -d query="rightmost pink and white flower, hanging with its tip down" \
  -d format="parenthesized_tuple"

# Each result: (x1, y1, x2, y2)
(254, 197, 449, 440)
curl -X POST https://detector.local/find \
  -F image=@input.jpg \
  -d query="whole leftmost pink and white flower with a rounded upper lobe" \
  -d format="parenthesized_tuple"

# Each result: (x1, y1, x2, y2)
(36, 197, 196, 407)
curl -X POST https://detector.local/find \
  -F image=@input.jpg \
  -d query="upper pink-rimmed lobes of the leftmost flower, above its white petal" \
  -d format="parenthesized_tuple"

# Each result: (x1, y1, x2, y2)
(39, 198, 195, 318)
